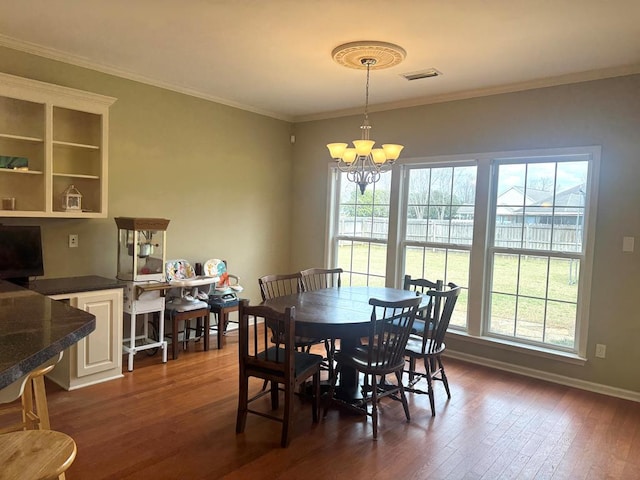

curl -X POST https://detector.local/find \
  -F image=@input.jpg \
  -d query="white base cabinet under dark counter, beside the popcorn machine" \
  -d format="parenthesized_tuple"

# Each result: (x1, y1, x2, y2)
(47, 288, 123, 390)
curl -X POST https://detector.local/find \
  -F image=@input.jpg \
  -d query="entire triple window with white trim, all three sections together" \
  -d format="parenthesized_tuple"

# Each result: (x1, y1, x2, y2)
(329, 147, 600, 357)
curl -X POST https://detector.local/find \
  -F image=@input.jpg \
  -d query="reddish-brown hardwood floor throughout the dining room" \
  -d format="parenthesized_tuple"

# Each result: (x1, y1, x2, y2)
(6, 333, 640, 480)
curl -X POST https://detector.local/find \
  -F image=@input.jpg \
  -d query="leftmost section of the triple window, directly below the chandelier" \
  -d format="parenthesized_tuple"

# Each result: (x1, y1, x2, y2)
(333, 173, 391, 286)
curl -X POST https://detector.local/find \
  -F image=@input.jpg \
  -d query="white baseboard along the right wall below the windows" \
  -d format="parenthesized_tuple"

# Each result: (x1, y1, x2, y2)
(446, 349, 640, 402)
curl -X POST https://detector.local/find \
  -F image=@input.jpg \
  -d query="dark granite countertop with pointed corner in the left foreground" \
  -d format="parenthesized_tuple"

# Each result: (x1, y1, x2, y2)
(0, 280, 96, 388)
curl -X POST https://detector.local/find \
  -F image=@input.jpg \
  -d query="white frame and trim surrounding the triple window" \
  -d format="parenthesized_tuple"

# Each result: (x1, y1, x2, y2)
(326, 146, 601, 364)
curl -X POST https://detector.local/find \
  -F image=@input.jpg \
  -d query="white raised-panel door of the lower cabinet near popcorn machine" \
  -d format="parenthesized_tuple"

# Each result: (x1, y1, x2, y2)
(77, 290, 122, 377)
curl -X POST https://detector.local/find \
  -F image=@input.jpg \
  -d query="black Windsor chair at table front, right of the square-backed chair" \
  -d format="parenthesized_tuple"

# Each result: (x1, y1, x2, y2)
(324, 296, 421, 440)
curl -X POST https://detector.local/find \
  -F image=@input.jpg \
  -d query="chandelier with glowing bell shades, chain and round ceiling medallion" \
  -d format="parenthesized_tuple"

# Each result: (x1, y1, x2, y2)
(327, 41, 406, 194)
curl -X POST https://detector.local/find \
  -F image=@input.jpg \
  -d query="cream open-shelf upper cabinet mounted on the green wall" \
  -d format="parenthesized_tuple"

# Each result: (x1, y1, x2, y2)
(0, 73, 116, 218)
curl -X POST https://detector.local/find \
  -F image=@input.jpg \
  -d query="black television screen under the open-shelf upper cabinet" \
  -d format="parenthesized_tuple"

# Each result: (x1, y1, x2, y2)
(0, 225, 44, 285)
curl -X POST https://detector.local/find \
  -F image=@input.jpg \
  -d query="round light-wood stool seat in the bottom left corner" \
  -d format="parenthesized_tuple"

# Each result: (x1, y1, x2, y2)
(0, 430, 77, 480)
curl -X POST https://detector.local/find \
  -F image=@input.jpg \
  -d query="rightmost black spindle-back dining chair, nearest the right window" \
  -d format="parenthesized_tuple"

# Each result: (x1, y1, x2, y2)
(405, 283, 461, 417)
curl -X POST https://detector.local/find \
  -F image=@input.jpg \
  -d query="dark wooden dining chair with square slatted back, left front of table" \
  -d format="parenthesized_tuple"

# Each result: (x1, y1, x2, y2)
(236, 300, 322, 447)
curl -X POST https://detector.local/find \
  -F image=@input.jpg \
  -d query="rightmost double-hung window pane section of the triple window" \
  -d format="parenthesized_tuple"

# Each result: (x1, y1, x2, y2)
(486, 156, 589, 351)
